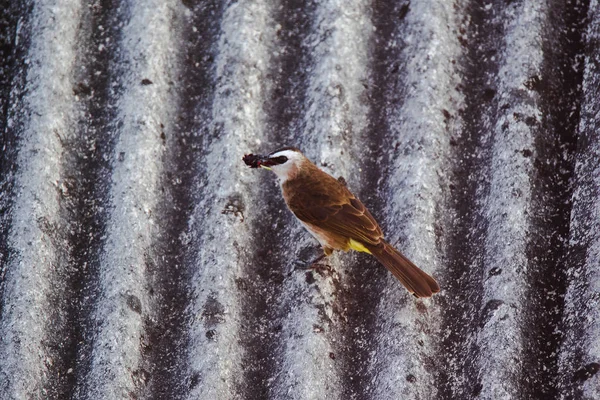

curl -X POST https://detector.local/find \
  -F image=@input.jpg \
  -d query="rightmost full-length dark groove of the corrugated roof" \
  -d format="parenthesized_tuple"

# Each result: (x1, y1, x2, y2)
(519, 1, 588, 399)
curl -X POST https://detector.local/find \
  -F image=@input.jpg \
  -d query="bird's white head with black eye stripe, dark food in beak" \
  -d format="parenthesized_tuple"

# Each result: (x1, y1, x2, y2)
(243, 147, 308, 182)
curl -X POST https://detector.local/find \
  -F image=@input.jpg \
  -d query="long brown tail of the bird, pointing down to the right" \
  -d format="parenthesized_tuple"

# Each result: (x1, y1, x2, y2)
(366, 240, 440, 297)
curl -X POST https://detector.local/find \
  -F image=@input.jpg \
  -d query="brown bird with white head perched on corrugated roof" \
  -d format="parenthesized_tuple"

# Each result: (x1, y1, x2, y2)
(242, 147, 440, 298)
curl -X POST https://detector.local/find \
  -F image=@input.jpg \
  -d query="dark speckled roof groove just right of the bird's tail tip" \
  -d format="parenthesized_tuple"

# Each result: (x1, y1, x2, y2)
(436, 1, 503, 399)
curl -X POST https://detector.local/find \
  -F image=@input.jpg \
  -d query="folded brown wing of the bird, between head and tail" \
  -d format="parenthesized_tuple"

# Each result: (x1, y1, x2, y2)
(284, 171, 383, 245)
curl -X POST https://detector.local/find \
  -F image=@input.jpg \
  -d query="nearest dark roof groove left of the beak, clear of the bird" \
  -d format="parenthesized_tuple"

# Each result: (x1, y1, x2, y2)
(144, 1, 222, 399)
